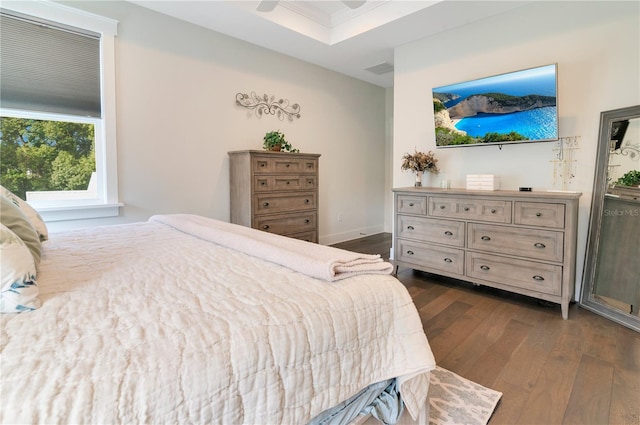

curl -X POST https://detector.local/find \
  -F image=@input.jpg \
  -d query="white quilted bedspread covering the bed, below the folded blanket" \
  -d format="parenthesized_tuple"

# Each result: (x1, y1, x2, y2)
(0, 217, 435, 424)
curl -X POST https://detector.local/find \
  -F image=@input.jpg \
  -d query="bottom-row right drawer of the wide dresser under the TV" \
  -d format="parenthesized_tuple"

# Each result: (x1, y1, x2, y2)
(467, 252, 562, 296)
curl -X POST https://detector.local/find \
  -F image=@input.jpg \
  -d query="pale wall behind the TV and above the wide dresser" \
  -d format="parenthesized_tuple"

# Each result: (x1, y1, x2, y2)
(396, 1, 640, 294)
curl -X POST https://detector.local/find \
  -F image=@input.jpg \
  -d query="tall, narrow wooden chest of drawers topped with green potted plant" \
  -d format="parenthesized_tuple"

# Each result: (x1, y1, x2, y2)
(229, 150, 320, 243)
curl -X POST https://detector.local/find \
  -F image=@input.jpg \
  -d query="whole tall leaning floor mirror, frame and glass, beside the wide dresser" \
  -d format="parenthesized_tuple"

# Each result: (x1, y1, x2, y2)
(580, 105, 640, 332)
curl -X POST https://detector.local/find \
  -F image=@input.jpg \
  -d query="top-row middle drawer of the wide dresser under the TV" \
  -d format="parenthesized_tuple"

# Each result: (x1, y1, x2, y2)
(429, 197, 511, 223)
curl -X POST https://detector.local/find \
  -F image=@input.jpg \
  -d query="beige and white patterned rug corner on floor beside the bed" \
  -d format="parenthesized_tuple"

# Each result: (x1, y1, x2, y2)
(428, 366, 502, 425)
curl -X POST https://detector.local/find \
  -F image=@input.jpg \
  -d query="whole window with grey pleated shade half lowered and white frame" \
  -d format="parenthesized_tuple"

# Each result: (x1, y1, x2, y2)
(0, 1, 121, 221)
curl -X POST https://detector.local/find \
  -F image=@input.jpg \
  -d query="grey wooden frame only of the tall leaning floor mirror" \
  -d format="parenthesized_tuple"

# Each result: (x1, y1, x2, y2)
(580, 105, 640, 332)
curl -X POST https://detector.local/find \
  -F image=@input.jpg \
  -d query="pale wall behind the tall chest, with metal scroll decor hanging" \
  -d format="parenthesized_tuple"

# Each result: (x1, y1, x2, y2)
(50, 1, 388, 243)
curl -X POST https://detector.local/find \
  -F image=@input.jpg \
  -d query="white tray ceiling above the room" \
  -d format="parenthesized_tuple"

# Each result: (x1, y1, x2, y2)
(130, 0, 531, 87)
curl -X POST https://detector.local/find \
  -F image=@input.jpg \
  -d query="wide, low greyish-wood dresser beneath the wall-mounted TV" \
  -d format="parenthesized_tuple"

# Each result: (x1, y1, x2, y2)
(393, 187, 581, 319)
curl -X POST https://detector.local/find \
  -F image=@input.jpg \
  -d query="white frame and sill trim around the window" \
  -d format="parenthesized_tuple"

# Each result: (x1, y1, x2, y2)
(1, 0, 123, 221)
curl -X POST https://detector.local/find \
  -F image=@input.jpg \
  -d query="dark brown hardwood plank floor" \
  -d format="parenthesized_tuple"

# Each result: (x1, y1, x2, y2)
(334, 233, 640, 425)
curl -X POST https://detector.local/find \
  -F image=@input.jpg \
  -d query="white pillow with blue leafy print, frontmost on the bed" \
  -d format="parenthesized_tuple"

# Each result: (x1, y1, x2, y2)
(0, 224, 40, 313)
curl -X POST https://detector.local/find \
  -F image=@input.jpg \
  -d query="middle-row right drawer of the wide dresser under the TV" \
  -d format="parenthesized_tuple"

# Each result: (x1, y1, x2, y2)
(467, 223, 564, 262)
